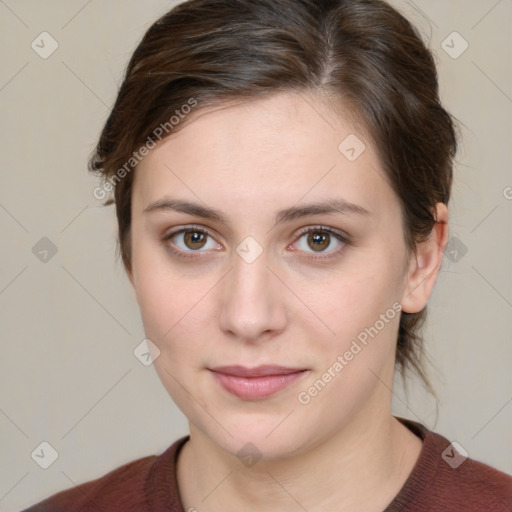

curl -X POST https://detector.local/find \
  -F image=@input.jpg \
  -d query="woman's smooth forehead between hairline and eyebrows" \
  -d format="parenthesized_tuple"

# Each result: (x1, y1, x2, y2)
(134, 92, 396, 218)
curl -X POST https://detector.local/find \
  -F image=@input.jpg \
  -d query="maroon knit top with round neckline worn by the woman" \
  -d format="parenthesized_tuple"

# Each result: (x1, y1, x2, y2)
(23, 418, 512, 512)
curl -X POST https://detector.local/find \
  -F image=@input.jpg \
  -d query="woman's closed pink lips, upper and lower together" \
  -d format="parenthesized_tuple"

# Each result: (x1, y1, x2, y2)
(210, 365, 306, 400)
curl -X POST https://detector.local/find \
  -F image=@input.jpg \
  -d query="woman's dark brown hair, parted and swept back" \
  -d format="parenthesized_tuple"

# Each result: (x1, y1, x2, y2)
(89, 0, 457, 390)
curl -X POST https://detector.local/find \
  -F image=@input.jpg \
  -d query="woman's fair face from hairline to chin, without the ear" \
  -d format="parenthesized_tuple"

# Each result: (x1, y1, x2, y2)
(130, 93, 416, 459)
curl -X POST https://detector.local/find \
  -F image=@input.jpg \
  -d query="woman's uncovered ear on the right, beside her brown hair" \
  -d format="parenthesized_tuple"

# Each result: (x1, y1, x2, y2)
(402, 203, 448, 313)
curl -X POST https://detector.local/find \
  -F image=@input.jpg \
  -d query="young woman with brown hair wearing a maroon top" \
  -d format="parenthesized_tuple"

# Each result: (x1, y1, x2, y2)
(24, 0, 512, 512)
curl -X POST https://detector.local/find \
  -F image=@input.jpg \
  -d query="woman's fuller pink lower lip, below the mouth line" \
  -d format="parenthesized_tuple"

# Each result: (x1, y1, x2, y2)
(212, 370, 306, 400)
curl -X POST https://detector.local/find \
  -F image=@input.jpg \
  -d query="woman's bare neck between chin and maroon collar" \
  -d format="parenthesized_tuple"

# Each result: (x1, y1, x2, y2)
(177, 402, 422, 512)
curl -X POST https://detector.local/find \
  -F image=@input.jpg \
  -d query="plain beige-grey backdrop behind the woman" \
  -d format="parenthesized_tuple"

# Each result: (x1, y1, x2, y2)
(0, 0, 512, 511)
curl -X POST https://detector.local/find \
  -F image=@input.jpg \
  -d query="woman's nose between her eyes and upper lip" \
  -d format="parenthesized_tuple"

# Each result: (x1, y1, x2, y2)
(219, 246, 287, 342)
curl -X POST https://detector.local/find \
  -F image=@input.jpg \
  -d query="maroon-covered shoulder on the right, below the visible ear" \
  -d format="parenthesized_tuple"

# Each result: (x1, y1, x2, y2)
(391, 418, 512, 512)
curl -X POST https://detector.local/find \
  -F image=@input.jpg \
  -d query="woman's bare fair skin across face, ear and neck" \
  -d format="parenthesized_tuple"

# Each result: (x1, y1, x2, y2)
(129, 92, 448, 512)
